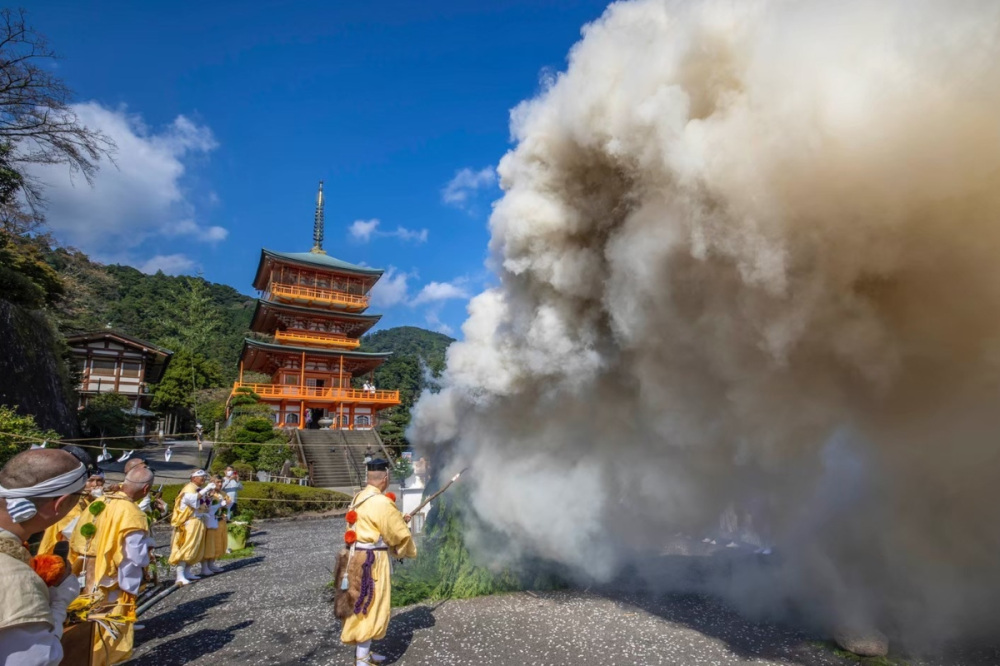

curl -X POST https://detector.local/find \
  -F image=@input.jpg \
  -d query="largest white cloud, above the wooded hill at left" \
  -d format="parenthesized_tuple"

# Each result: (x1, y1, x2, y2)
(32, 102, 223, 254)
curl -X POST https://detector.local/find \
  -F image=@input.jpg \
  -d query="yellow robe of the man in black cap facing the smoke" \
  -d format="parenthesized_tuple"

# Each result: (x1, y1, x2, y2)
(340, 486, 417, 643)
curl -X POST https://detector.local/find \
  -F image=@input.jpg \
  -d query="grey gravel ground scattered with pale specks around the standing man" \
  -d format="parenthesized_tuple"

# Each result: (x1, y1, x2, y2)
(130, 519, 995, 666)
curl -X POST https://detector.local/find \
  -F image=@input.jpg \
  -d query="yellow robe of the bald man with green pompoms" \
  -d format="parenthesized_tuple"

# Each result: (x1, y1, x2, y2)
(91, 493, 149, 666)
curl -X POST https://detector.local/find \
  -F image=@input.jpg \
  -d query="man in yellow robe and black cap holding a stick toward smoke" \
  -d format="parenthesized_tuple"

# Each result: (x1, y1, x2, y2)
(340, 460, 417, 666)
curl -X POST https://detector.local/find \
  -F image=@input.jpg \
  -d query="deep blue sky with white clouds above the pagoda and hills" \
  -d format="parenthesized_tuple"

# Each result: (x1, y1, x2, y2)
(28, 0, 605, 335)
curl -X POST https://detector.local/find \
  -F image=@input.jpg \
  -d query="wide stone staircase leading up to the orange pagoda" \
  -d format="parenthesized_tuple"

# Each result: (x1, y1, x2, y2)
(295, 429, 388, 491)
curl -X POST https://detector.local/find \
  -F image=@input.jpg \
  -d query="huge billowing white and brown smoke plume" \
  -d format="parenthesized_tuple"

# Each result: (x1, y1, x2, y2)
(411, 0, 1000, 640)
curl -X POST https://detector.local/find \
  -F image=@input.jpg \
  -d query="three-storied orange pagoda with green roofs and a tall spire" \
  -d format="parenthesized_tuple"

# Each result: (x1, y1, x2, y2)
(233, 182, 399, 430)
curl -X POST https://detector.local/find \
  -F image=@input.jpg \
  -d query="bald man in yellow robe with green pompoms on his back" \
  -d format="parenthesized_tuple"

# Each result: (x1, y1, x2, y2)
(87, 466, 153, 666)
